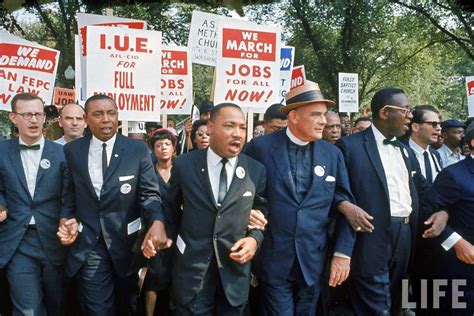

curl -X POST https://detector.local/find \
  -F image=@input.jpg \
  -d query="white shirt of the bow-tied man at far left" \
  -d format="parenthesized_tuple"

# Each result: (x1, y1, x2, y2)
(18, 137, 44, 225)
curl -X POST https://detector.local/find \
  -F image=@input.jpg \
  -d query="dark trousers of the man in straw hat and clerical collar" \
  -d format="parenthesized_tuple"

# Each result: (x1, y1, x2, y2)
(260, 259, 321, 316)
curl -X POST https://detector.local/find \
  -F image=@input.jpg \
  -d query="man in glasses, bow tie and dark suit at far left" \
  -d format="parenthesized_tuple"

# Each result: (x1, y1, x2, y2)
(0, 93, 68, 315)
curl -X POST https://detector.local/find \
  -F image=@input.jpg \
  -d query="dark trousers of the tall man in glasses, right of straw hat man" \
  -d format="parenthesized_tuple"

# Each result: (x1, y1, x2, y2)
(350, 220, 411, 316)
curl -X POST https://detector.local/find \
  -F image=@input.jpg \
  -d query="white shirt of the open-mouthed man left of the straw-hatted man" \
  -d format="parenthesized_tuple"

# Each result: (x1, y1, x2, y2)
(207, 147, 237, 203)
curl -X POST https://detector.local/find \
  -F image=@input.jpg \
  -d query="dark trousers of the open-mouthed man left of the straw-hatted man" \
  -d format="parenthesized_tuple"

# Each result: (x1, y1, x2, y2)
(173, 257, 246, 316)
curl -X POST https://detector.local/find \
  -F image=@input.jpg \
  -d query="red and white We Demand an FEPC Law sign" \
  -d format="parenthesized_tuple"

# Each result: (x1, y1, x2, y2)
(0, 31, 59, 111)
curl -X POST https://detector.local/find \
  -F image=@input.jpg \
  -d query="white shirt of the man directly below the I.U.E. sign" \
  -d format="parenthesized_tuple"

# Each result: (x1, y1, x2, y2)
(87, 134, 117, 199)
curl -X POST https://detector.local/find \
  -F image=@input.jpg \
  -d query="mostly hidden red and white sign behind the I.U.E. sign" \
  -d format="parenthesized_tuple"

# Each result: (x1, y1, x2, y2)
(76, 13, 146, 100)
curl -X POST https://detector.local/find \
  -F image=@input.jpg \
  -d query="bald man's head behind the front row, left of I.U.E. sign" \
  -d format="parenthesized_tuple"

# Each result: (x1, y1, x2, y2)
(56, 103, 87, 145)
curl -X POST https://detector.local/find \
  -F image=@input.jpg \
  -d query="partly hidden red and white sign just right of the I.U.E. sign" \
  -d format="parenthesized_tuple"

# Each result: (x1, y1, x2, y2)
(160, 46, 193, 115)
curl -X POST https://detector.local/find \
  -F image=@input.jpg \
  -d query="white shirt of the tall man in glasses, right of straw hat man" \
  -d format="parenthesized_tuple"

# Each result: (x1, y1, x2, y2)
(371, 124, 412, 217)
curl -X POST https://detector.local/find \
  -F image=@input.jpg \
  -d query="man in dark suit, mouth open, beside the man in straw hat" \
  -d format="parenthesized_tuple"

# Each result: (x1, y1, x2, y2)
(165, 103, 265, 315)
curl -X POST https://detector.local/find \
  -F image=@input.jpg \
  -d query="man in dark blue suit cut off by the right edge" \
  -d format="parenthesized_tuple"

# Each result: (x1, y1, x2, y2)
(434, 123, 474, 315)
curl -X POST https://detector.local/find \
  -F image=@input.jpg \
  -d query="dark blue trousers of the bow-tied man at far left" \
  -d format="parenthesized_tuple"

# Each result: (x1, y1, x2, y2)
(6, 226, 65, 315)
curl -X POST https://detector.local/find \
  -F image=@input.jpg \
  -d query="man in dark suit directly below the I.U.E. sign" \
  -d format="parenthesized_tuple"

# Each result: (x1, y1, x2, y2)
(58, 95, 169, 315)
